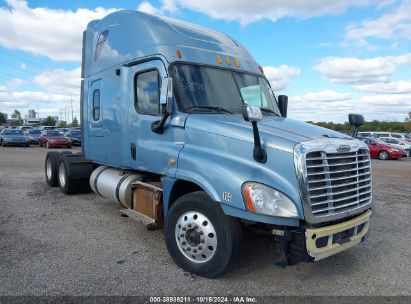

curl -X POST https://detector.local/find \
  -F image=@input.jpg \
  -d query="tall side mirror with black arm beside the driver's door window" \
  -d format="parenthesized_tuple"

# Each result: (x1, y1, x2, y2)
(151, 77, 173, 134)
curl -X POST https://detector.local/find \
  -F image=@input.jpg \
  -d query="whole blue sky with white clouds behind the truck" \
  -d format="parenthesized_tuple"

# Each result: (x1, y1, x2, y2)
(0, 0, 411, 122)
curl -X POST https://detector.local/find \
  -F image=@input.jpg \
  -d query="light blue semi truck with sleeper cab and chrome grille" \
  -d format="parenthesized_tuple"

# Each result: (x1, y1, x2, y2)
(45, 11, 372, 277)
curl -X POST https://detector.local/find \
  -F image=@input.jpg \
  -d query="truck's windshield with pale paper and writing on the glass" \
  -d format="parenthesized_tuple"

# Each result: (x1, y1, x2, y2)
(172, 64, 281, 116)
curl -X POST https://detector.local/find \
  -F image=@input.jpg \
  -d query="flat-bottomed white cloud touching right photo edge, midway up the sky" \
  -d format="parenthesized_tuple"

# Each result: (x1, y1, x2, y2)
(315, 53, 411, 84)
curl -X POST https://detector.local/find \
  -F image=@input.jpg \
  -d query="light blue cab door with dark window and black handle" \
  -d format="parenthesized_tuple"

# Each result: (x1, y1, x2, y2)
(124, 59, 182, 175)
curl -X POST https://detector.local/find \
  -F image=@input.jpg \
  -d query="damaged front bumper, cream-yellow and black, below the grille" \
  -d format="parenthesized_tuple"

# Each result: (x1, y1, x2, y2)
(272, 209, 372, 266)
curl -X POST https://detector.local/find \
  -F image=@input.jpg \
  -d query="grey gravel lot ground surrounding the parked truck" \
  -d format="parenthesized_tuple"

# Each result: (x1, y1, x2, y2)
(0, 147, 411, 296)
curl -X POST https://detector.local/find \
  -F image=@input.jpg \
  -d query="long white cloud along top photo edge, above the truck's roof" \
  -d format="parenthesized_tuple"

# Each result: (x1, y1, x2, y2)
(144, 0, 386, 25)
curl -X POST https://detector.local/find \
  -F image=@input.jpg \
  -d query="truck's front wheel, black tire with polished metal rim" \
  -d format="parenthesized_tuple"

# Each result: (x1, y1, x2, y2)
(164, 192, 241, 277)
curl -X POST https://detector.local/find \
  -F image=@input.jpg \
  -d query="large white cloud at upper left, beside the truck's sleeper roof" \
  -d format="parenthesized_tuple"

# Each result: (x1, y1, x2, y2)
(0, 0, 116, 62)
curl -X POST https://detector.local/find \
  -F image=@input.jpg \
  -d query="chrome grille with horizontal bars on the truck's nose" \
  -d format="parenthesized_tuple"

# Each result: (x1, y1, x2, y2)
(306, 149, 372, 216)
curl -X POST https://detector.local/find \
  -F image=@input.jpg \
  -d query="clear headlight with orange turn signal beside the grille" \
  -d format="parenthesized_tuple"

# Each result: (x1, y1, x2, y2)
(242, 182, 298, 218)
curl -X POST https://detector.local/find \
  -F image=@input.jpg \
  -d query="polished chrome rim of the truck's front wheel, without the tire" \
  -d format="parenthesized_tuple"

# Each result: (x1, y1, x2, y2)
(175, 211, 217, 263)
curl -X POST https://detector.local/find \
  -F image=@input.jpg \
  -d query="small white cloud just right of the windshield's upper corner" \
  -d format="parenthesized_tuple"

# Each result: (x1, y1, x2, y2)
(263, 65, 301, 92)
